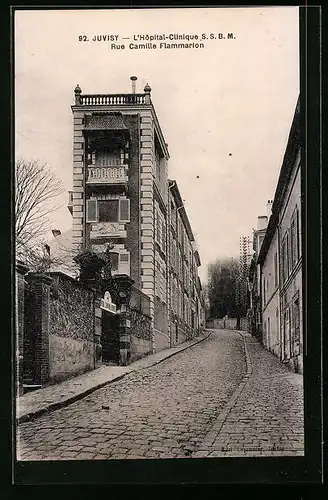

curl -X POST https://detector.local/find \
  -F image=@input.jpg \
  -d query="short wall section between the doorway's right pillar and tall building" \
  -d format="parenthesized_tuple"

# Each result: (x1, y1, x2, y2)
(129, 309, 153, 362)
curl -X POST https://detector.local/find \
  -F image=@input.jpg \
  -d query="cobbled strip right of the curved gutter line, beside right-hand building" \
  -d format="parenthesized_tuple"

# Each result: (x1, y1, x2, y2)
(195, 336, 304, 456)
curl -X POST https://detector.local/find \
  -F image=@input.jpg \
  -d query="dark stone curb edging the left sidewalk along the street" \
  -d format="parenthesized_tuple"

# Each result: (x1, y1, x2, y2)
(16, 331, 213, 424)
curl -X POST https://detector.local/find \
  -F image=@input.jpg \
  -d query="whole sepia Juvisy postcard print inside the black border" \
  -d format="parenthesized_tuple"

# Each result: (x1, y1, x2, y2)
(13, 6, 320, 474)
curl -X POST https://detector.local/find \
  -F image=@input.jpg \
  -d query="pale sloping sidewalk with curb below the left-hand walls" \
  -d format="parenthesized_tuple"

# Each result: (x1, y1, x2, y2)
(16, 330, 211, 422)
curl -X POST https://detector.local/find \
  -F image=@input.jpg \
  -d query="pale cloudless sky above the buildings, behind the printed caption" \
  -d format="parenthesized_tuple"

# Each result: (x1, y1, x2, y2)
(14, 7, 299, 282)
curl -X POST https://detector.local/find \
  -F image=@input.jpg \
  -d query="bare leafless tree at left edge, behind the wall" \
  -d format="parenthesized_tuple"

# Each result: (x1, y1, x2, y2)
(15, 158, 63, 255)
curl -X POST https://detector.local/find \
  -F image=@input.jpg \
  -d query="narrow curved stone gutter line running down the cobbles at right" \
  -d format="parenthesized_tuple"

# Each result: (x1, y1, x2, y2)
(193, 330, 253, 452)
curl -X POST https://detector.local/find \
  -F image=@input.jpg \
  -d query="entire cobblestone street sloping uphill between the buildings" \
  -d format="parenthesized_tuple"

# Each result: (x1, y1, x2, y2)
(18, 330, 303, 460)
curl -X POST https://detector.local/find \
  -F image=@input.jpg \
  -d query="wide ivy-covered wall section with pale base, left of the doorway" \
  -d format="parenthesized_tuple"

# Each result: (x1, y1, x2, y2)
(49, 273, 95, 382)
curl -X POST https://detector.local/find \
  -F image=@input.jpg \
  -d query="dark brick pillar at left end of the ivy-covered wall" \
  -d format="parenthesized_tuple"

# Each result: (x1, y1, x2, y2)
(24, 273, 52, 385)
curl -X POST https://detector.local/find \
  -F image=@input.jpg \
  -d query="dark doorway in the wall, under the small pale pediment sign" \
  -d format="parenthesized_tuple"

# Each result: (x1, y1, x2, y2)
(101, 310, 120, 364)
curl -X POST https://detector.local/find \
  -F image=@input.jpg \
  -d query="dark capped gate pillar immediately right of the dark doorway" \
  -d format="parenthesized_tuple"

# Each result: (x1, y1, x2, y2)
(114, 274, 134, 366)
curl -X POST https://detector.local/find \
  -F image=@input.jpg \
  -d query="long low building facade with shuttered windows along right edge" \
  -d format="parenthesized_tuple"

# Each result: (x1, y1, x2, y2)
(257, 97, 303, 373)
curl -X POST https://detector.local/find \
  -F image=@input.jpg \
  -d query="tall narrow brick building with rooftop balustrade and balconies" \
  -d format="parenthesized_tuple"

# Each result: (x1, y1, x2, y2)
(70, 77, 202, 351)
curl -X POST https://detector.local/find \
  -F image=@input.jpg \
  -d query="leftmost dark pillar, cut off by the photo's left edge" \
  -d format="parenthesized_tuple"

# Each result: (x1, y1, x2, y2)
(15, 261, 29, 395)
